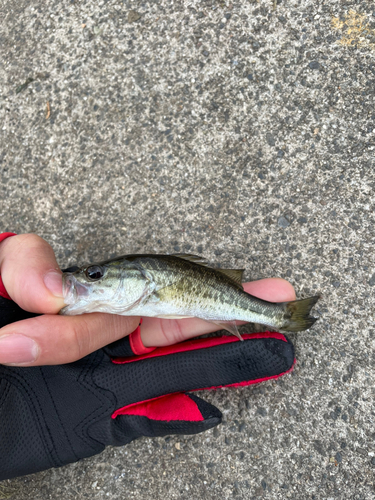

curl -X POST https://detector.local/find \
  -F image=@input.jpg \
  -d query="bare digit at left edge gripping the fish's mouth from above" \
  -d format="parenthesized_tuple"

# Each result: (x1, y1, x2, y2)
(0, 234, 64, 314)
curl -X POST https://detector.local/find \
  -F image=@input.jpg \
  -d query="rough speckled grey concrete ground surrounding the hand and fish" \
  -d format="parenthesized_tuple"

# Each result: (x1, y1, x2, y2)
(0, 0, 375, 500)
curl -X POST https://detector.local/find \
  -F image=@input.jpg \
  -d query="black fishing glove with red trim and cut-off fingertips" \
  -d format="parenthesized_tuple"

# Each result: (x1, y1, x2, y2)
(0, 297, 294, 480)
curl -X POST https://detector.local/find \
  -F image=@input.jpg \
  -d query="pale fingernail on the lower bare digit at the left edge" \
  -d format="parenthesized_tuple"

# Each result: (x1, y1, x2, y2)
(0, 333, 39, 365)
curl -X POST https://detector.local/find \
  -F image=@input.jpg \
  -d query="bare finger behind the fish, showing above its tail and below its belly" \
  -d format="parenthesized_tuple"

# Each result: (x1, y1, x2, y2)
(141, 278, 296, 347)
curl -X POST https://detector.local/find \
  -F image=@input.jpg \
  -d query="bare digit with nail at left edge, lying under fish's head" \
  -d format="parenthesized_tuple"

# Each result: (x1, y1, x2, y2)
(0, 313, 139, 366)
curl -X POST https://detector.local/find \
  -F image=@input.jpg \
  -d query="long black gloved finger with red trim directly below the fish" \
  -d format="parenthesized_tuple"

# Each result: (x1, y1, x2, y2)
(111, 332, 294, 406)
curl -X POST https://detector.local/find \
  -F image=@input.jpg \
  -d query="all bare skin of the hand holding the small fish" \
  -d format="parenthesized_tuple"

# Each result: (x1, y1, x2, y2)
(0, 234, 295, 366)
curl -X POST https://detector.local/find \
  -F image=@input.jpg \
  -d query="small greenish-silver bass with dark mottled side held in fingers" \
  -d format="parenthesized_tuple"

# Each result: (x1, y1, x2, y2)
(60, 254, 319, 340)
